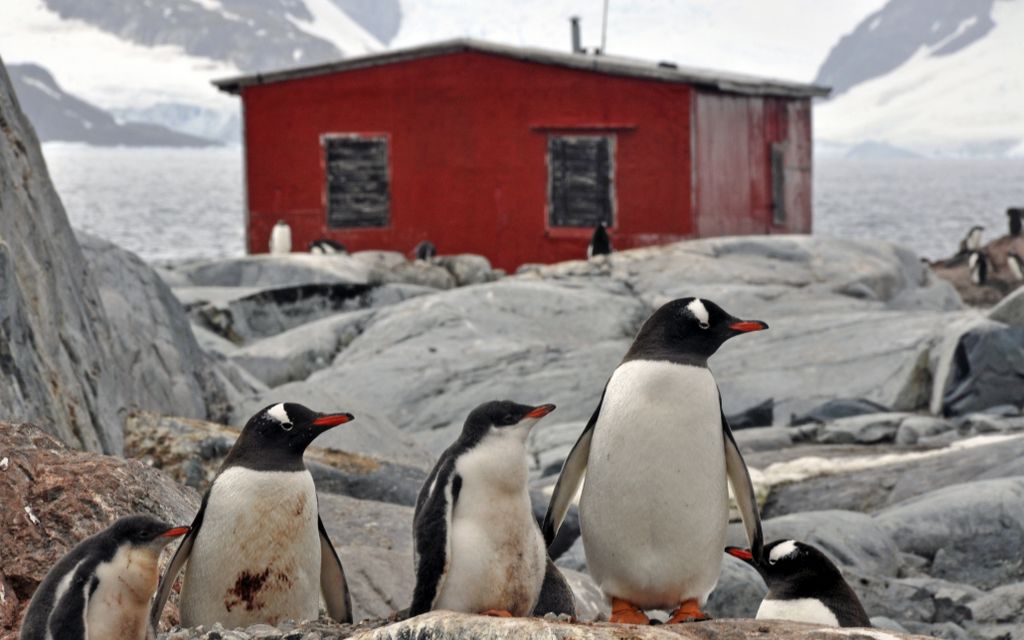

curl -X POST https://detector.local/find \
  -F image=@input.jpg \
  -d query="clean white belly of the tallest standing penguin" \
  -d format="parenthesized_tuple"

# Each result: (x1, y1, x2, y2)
(580, 360, 729, 608)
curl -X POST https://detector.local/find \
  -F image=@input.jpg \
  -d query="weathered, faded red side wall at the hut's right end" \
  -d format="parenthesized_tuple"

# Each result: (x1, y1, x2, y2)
(693, 91, 811, 237)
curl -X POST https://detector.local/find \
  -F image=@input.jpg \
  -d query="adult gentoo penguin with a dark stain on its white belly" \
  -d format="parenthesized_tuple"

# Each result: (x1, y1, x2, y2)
(153, 402, 352, 629)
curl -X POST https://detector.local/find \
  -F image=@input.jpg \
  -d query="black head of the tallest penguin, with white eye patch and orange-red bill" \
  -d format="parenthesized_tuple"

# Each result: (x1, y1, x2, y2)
(626, 298, 768, 364)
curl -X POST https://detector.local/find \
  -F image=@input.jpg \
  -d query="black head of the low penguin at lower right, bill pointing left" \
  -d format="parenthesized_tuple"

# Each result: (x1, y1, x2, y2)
(725, 540, 843, 592)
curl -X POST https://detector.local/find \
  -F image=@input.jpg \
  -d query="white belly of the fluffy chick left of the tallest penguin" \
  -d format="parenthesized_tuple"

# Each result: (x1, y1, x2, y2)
(434, 433, 546, 615)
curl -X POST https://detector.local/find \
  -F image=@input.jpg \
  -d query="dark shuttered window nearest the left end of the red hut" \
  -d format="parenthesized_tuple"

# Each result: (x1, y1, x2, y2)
(324, 135, 391, 228)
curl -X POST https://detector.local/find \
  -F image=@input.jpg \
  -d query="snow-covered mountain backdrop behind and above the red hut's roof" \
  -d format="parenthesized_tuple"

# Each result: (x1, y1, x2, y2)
(0, 0, 1024, 155)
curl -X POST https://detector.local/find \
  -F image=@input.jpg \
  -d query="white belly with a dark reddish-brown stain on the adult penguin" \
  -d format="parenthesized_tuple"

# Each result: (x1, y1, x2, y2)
(180, 467, 321, 629)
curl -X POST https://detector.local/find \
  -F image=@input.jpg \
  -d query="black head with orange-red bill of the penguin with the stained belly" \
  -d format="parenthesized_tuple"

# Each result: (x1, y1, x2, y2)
(224, 402, 352, 469)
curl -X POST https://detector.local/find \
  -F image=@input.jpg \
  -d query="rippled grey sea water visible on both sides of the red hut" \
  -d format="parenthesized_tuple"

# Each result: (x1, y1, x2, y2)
(43, 143, 1024, 261)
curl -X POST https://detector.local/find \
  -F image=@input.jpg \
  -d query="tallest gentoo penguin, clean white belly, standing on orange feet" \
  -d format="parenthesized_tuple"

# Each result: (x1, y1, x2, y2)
(543, 298, 768, 624)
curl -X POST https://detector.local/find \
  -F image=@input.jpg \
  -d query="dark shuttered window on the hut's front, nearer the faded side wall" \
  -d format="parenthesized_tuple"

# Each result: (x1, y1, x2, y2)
(548, 135, 615, 227)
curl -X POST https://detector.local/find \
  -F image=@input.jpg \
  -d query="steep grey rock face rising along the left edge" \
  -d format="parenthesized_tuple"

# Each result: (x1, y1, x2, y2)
(0, 57, 129, 453)
